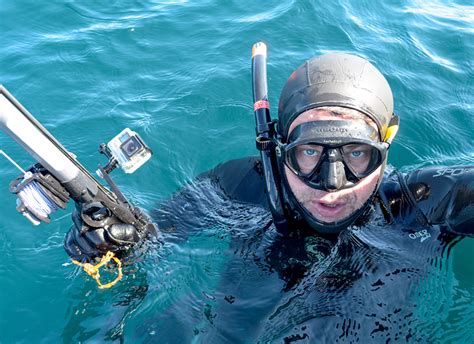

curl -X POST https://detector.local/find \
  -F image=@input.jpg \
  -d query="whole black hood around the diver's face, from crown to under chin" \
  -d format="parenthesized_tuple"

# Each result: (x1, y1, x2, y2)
(278, 53, 393, 234)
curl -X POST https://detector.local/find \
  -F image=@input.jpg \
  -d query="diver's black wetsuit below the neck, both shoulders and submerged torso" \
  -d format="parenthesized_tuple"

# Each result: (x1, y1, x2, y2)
(142, 158, 474, 343)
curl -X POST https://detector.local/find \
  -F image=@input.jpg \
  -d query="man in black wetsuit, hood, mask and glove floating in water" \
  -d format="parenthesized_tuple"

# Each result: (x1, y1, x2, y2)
(64, 53, 474, 342)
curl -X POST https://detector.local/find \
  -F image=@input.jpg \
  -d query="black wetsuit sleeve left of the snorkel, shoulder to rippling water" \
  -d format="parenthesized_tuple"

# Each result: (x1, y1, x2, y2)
(152, 157, 268, 242)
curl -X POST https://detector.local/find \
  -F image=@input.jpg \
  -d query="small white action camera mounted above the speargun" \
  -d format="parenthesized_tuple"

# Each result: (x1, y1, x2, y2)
(107, 128, 152, 173)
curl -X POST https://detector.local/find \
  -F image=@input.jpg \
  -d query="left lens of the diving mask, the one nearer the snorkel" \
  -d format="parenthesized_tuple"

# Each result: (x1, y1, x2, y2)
(287, 144, 323, 175)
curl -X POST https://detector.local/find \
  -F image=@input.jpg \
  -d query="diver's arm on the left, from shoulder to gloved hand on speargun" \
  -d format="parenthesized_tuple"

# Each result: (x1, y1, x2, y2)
(64, 157, 267, 260)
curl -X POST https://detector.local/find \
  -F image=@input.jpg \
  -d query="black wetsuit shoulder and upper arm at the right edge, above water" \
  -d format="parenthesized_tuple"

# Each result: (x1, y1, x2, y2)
(380, 166, 474, 236)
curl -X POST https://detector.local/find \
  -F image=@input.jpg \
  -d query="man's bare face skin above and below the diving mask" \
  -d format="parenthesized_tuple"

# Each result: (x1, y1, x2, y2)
(285, 109, 381, 223)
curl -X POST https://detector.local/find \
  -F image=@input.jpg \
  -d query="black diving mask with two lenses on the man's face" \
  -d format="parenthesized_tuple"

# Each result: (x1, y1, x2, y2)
(277, 120, 389, 191)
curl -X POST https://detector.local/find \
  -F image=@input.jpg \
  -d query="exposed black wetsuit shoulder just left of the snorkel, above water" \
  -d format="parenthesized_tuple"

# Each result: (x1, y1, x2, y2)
(200, 157, 268, 208)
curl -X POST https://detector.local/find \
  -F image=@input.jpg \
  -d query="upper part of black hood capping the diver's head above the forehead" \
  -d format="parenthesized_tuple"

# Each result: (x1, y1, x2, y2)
(278, 53, 393, 139)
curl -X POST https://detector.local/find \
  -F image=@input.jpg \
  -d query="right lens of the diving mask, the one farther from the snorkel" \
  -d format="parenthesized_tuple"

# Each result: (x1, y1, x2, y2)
(341, 144, 382, 177)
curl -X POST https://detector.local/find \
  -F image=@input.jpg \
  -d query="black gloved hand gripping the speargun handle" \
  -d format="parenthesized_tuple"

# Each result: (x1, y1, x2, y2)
(64, 206, 146, 261)
